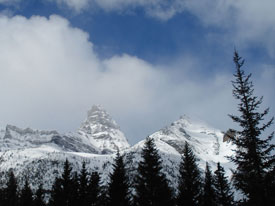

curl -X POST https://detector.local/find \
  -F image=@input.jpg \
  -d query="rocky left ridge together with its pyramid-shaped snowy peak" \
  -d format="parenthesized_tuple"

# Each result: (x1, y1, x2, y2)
(0, 106, 130, 154)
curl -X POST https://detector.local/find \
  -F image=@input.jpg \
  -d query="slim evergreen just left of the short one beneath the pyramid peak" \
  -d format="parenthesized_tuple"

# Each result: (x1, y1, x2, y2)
(79, 161, 89, 206)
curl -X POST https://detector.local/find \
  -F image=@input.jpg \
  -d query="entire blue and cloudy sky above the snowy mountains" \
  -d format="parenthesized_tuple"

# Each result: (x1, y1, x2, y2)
(0, 0, 275, 144)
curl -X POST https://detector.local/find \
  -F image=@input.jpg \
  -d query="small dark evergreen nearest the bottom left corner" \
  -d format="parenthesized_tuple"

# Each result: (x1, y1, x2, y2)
(3, 171, 18, 206)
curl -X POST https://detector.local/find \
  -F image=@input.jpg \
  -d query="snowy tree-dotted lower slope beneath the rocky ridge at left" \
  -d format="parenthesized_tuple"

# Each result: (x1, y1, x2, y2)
(0, 145, 115, 189)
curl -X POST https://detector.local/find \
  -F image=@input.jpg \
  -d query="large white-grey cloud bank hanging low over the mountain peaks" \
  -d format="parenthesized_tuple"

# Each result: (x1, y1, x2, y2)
(0, 15, 275, 143)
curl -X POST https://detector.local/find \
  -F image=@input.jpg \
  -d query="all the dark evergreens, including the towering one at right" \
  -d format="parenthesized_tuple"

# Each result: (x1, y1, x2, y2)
(0, 52, 275, 206)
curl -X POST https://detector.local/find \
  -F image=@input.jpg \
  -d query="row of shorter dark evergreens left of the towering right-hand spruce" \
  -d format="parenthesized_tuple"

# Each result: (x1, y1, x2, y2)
(0, 138, 237, 206)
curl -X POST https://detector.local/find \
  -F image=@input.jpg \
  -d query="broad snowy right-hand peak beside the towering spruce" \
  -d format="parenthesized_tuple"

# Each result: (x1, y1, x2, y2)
(150, 116, 233, 174)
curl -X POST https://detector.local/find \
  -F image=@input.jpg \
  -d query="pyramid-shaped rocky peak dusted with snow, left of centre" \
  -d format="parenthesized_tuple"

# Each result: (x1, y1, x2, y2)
(78, 105, 130, 154)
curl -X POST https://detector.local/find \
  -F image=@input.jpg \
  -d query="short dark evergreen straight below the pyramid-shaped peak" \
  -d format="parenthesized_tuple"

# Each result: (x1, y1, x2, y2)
(87, 172, 103, 206)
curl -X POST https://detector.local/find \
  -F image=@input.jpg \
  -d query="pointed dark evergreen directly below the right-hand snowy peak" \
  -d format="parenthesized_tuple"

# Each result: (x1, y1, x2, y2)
(177, 142, 202, 206)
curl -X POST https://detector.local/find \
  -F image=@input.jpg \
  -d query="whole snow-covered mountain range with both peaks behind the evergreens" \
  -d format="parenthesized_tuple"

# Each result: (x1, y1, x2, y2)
(0, 106, 233, 192)
